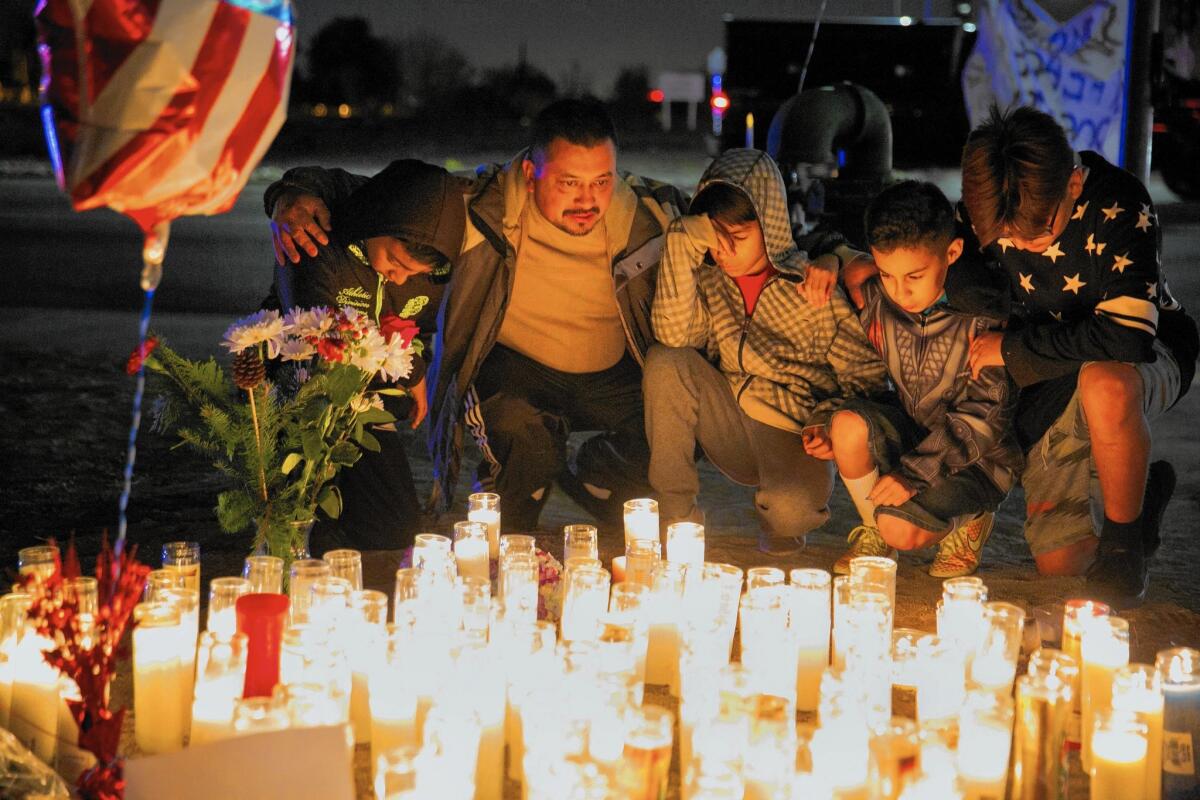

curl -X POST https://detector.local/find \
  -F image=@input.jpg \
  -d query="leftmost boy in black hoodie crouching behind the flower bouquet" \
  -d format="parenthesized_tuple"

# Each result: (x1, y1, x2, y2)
(263, 160, 469, 552)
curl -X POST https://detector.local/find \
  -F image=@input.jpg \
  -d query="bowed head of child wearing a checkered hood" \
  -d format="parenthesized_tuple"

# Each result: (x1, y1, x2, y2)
(689, 149, 805, 277)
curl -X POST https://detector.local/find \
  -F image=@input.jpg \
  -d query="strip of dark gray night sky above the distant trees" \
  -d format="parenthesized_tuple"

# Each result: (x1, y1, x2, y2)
(296, 0, 955, 95)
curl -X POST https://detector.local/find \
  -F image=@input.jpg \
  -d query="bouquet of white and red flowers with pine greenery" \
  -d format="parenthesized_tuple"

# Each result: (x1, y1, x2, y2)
(135, 307, 416, 561)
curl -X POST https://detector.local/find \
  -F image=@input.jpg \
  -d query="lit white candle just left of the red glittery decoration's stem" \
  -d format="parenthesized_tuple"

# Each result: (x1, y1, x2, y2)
(8, 630, 61, 764)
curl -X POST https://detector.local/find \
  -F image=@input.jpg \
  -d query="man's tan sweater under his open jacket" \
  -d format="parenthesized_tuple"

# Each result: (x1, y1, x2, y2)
(498, 197, 625, 373)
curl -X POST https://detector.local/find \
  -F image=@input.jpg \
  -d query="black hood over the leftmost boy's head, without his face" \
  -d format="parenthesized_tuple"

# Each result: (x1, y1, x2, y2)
(334, 158, 469, 261)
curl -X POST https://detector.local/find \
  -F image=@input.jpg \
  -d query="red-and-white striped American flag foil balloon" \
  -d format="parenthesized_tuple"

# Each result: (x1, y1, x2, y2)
(35, 0, 295, 235)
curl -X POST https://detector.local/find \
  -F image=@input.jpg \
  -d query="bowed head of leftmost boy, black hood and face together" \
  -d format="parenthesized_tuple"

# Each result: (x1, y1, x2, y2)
(334, 158, 467, 283)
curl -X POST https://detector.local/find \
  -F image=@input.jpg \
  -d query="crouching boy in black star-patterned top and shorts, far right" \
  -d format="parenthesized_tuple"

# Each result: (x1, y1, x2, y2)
(947, 107, 1200, 607)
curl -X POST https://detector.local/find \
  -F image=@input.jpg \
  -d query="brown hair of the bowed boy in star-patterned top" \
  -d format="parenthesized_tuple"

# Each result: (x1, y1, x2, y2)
(962, 106, 1075, 247)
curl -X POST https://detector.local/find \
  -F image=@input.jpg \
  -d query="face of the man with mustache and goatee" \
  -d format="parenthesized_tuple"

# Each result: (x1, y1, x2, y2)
(522, 139, 617, 236)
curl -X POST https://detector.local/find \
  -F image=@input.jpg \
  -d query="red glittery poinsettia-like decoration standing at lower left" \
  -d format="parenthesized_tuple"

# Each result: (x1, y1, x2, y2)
(25, 537, 150, 800)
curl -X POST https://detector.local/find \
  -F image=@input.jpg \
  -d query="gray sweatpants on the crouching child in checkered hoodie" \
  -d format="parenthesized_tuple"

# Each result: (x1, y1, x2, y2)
(642, 344, 833, 537)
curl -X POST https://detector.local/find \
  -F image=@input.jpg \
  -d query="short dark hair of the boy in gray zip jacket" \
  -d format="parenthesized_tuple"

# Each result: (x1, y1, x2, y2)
(863, 181, 955, 253)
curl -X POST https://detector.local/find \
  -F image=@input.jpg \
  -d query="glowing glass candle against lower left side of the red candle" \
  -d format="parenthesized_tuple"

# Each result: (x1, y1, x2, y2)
(190, 631, 247, 745)
